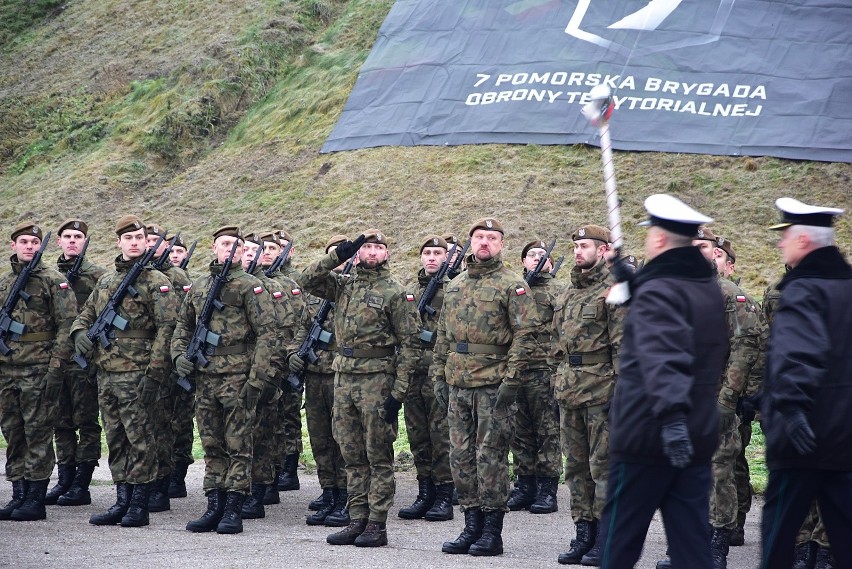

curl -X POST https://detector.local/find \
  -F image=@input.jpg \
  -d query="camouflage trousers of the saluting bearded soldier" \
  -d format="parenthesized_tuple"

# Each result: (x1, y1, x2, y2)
(332, 372, 398, 522)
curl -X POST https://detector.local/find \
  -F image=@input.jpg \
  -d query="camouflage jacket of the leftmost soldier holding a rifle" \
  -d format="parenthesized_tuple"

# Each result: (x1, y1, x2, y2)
(0, 255, 77, 369)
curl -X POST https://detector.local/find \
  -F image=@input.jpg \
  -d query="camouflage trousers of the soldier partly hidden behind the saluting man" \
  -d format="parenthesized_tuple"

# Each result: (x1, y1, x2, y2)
(305, 371, 346, 488)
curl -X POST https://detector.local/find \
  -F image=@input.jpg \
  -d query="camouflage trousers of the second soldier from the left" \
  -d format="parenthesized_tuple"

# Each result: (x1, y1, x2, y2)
(54, 363, 101, 464)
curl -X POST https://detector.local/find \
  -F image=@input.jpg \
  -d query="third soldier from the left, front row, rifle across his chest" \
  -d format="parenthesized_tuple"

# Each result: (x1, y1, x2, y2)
(71, 215, 177, 527)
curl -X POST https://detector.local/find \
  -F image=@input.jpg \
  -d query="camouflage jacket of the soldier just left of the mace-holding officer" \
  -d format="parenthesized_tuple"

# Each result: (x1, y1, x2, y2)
(551, 262, 627, 407)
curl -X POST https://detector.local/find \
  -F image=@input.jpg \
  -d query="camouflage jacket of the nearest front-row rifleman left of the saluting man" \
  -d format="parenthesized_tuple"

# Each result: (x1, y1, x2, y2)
(171, 261, 283, 385)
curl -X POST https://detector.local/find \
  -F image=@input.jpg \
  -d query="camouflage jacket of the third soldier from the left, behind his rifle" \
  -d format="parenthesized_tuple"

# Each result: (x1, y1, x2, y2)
(71, 255, 177, 374)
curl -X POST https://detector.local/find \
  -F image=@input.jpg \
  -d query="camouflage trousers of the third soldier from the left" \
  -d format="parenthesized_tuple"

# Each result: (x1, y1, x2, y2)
(98, 370, 157, 484)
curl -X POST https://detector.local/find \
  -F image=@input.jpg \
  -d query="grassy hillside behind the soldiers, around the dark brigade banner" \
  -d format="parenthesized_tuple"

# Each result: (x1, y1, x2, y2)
(0, 0, 852, 295)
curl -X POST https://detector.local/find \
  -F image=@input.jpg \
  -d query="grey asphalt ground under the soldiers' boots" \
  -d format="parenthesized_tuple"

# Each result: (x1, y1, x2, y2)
(0, 461, 760, 569)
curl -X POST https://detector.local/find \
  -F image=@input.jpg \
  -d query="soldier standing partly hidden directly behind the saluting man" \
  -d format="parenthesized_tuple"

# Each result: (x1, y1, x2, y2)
(290, 235, 352, 527)
